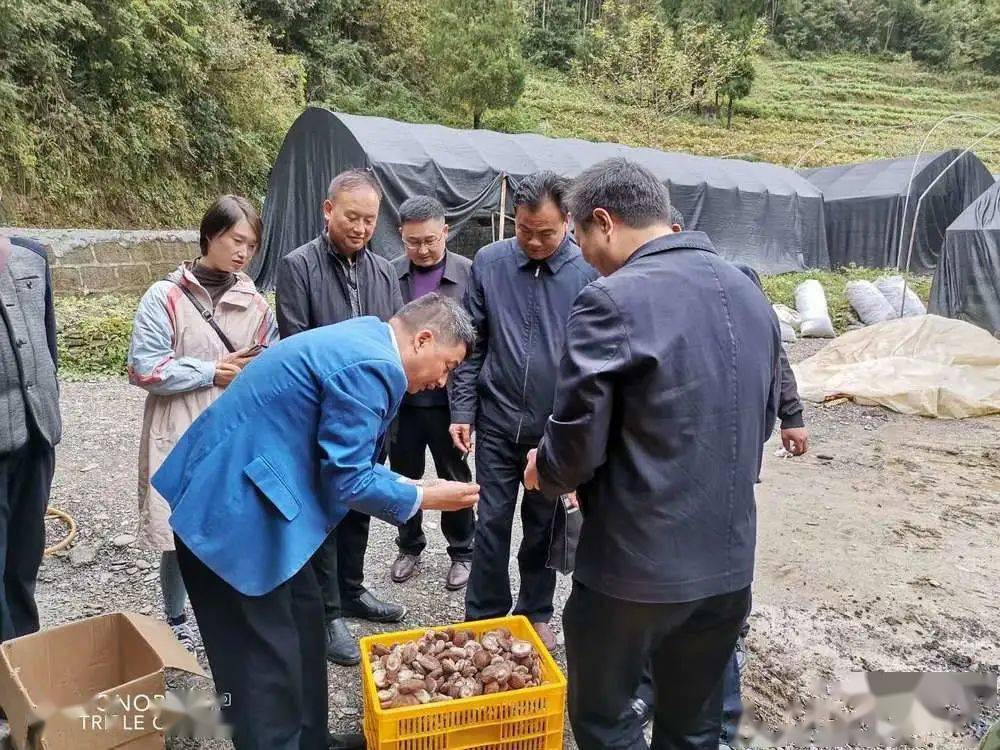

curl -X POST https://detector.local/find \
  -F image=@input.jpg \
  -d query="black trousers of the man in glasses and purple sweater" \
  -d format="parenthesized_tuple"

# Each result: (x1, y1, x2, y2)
(389, 404, 476, 562)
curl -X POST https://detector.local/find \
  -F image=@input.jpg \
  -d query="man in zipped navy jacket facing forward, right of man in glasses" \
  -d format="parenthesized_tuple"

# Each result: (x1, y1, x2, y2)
(451, 172, 596, 648)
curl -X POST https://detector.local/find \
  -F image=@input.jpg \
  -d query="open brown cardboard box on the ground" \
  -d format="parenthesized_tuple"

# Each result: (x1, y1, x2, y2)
(0, 612, 204, 750)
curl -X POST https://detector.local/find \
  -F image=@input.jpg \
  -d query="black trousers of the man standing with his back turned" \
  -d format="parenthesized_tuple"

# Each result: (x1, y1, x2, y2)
(563, 581, 750, 750)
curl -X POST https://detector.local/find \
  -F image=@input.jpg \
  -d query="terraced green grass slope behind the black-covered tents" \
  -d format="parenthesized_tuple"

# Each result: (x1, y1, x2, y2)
(508, 55, 1000, 172)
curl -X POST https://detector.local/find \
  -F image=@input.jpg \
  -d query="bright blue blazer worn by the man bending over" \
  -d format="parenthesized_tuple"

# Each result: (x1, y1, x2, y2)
(153, 317, 417, 596)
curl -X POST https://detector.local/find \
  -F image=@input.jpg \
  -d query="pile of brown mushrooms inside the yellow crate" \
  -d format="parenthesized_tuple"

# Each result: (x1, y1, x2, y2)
(371, 628, 542, 708)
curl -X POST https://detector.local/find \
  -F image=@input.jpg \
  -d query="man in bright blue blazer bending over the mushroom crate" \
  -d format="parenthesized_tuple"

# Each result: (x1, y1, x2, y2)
(152, 302, 478, 750)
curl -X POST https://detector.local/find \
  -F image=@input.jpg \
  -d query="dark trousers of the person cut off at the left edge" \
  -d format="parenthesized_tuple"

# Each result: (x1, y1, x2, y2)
(0, 435, 55, 641)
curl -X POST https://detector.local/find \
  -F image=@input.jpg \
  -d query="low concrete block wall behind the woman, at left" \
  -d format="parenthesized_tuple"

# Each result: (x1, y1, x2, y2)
(0, 227, 201, 294)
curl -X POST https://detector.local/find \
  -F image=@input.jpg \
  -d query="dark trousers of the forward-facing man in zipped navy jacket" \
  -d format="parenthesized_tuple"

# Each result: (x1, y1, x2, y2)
(465, 430, 556, 622)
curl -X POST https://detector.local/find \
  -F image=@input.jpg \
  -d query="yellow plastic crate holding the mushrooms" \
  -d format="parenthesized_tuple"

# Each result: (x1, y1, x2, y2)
(361, 616, 566, 750)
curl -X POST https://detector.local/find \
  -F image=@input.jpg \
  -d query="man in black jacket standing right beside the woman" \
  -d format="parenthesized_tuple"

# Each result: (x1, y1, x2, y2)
(276, 169, 406, 665)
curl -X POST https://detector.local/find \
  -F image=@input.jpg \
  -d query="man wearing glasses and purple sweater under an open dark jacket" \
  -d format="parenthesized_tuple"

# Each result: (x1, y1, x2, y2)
(389, 196, 476, 591)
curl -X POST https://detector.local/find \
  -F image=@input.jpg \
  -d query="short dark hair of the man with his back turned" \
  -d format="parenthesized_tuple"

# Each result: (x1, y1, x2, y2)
(567, 158, 672, 229)
